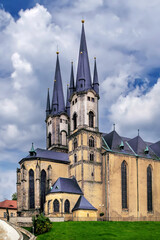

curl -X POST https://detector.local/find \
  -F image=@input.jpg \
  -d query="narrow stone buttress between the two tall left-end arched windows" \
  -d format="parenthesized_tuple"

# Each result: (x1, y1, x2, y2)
(35, 162, 40, 209)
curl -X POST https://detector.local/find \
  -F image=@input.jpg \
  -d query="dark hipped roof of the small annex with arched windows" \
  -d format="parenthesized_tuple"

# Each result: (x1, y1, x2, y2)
(48, 177, 83, 195)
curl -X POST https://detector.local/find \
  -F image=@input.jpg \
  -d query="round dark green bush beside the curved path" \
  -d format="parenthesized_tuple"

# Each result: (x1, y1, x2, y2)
(32, 214, 52, 235)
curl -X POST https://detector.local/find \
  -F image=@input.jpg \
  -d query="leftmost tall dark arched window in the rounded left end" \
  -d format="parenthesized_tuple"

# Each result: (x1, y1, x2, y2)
(29, 169, 35, 208)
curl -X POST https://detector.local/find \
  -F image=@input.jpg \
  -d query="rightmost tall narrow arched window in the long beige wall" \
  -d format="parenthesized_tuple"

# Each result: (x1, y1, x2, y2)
(147, 166, 153, 212)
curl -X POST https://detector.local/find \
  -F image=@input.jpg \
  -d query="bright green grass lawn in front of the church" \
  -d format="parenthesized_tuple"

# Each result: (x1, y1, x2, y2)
(37, 222, 160, 240)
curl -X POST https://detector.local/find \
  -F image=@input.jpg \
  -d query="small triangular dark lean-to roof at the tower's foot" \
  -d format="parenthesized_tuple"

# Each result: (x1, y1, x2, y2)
(72, 196, 97, 212)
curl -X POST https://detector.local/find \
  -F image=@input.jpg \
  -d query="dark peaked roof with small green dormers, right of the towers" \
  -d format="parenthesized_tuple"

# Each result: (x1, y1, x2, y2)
(103, 130, 160, 159)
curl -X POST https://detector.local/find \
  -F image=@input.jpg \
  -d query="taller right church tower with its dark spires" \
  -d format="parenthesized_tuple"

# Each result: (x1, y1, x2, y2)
(69, 20, 102, 207)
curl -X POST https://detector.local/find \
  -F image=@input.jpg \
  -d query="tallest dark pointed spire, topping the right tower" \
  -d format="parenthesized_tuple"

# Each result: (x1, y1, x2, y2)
(76, 21, 92, 91)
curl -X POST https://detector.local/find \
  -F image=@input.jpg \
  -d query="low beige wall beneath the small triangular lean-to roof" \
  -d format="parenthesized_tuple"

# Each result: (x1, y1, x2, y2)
(73, 210, 97, 221)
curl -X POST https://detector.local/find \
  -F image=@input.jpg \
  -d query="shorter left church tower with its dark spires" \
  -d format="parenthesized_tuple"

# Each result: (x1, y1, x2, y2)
(46, 52, 69, 152)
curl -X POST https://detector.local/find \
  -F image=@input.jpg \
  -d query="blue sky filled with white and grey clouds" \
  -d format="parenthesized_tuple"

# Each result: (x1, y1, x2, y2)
(0, 0, 160, 200)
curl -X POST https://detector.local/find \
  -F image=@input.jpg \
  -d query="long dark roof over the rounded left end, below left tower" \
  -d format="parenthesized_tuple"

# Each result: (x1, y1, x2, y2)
(20, 148, 69, 163)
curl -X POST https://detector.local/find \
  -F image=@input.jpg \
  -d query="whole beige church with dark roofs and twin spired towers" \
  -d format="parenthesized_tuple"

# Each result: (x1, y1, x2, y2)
(17, 20, 160, 221)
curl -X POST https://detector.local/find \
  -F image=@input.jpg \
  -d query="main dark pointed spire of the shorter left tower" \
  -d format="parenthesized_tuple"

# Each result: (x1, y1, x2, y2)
(52, 52, 65, 114)
